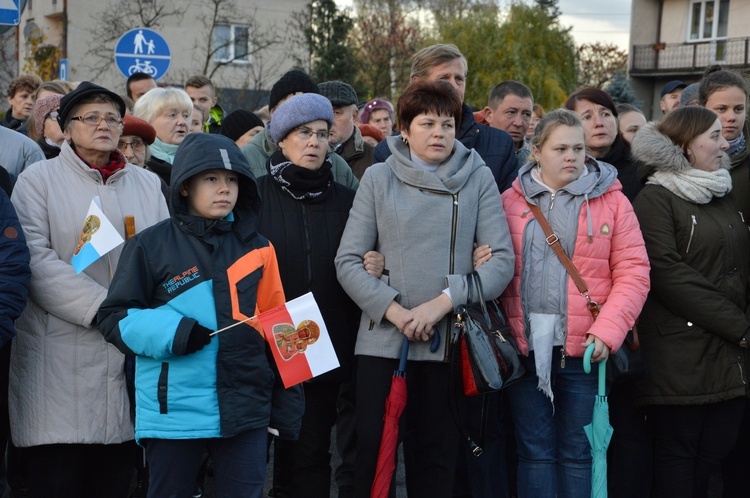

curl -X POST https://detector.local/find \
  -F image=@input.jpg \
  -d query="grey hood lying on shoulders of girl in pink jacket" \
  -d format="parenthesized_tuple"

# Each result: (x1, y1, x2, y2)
(513, 155, 622, 199)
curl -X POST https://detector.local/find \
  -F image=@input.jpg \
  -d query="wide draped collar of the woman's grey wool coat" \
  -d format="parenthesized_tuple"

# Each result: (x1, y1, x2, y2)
(386, 135, 485, 194)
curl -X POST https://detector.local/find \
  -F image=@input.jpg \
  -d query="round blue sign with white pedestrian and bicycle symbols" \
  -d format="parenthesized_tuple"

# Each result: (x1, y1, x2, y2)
(114, 27, 172, 80)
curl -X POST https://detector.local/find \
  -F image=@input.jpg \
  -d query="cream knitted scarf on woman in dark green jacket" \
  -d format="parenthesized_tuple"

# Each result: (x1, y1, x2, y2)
(646, 168, 732, 204)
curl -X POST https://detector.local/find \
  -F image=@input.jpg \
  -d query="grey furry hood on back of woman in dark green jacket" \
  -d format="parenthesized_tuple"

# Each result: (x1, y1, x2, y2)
(630, 121, 731, 183)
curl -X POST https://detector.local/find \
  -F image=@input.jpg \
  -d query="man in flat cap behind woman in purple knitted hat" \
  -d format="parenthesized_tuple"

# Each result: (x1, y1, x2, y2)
(318, 81, 373, 180)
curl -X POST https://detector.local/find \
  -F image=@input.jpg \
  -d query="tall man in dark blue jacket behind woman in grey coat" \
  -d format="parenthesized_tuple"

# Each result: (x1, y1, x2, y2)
(374, 44, 518, 192)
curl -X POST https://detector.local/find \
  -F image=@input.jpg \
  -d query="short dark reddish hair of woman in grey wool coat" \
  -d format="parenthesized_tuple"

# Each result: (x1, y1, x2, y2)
(398, 80, 462, 131)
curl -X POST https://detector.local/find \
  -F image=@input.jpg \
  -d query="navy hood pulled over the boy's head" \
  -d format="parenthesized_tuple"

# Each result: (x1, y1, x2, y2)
(169, 133, 260, 220)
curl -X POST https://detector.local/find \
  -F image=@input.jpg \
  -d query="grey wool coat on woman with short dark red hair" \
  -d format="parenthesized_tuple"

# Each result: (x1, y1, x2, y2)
(336, 137, 515, 361)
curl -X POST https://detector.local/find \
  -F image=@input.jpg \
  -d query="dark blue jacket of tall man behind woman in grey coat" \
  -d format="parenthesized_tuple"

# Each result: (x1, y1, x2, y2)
(373, 104, 518, 193)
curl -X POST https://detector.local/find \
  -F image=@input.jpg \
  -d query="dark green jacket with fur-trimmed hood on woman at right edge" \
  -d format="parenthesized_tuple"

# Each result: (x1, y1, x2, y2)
(633, 125, 750, 405)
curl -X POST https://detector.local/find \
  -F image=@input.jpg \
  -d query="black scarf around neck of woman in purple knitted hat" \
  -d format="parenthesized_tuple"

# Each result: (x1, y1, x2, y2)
(268, 151, 333, 201)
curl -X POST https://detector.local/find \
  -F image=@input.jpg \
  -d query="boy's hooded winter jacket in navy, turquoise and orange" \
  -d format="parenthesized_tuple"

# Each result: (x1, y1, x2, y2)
(98, 133, 304, 440)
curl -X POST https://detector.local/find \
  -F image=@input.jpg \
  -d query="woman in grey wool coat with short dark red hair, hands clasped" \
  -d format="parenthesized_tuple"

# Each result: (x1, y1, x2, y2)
(336, 81, 514, 498)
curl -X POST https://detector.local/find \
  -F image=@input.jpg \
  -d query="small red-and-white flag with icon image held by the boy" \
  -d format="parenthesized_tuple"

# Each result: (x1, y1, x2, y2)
(258, 292, 339, 388)
